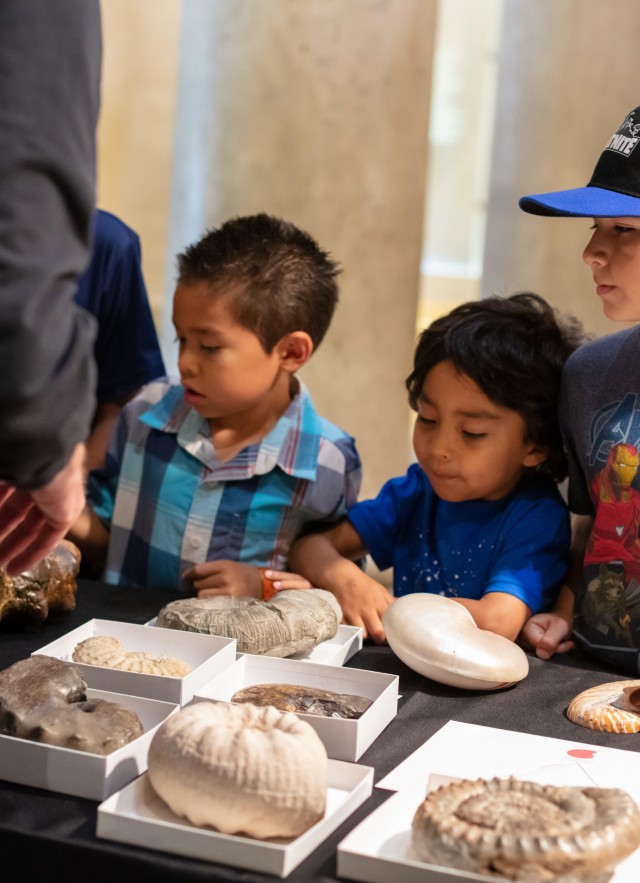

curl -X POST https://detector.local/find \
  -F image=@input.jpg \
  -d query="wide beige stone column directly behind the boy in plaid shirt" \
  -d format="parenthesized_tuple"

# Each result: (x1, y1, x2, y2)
(164, 0, 436, 495)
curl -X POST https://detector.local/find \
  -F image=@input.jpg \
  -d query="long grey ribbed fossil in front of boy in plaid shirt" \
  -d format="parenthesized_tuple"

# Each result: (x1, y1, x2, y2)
(157, 589, 342, 656)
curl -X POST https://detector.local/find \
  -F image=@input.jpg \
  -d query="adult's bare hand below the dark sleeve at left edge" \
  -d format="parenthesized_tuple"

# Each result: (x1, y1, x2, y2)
(0, 444, 85, 576)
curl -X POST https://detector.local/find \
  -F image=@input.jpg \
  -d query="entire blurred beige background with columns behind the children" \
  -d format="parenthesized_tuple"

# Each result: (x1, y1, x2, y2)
(98, 0, 640, 495)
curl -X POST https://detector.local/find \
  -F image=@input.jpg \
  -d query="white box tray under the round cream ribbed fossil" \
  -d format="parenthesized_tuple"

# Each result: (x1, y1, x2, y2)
(96, 760, 373, 877)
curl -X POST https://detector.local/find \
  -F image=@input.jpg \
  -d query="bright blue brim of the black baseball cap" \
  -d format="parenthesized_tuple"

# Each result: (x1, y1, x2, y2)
(518, 187, 640, 218)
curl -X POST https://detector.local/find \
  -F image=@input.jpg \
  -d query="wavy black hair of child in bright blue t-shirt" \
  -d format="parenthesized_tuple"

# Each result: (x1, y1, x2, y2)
(406, 292, 586, 481)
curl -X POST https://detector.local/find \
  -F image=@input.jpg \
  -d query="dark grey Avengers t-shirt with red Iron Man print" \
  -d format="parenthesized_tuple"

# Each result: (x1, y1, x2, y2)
(560, 328, 640, 676)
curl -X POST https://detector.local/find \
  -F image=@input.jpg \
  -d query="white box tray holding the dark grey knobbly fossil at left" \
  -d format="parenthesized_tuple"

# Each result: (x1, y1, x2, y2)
(0, 689, 179, 800)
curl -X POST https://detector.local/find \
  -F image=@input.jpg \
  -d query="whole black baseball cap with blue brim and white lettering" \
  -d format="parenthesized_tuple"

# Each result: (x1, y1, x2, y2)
(518, 107, 640, 218)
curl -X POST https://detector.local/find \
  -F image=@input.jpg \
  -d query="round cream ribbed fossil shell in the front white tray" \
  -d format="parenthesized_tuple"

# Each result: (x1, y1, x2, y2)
(148, 702, 327, 839)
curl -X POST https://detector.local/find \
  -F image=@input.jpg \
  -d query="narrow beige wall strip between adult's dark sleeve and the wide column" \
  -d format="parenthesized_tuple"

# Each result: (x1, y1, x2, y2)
(97, 0, 182, 323)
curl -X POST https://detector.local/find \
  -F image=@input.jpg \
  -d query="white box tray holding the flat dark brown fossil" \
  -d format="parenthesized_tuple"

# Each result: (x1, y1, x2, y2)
(193, 654, 398, 761)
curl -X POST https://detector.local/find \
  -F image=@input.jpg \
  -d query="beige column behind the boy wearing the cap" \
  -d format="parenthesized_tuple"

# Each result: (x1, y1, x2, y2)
(483, 0, 640, 334)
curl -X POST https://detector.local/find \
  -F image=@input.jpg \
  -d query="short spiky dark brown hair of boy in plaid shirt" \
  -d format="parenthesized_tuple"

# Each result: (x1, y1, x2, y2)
(178, 214, 340, 353)
